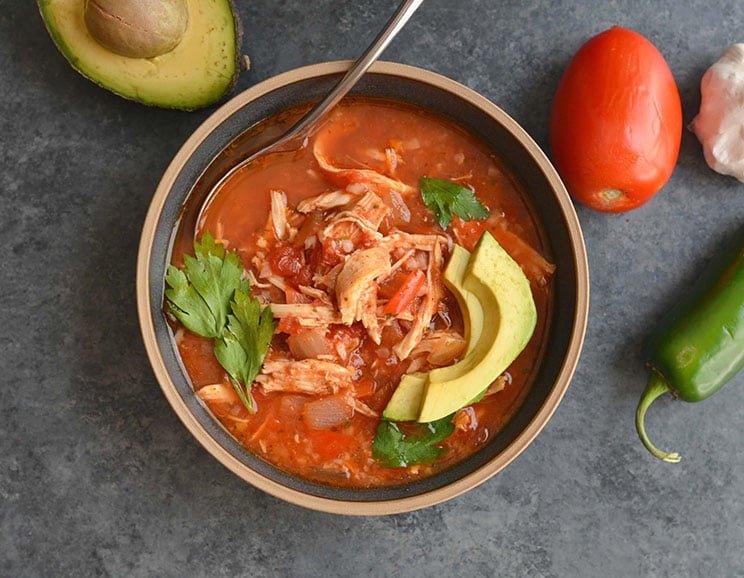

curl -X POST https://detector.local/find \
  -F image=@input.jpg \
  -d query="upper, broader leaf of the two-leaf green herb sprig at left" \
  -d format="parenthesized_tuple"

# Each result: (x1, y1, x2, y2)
(165, 233, 243, 339)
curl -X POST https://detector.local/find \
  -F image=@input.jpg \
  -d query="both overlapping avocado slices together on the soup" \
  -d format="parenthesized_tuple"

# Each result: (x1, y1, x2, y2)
(383, 233, 537, 422)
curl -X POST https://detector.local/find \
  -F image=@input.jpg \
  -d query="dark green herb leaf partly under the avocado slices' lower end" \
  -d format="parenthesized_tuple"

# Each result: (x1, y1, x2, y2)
(372, 414, 455, 468)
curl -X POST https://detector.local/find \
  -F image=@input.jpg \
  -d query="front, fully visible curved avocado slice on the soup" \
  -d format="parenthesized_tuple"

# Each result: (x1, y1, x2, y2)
(418, 232, 537, 422)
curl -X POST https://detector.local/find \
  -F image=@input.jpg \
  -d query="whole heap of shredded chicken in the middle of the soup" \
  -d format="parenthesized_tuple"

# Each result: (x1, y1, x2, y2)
(251, 130, 464, 400)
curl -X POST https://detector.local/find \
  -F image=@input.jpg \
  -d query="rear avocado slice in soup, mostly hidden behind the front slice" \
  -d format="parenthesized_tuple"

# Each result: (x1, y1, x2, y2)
(382, 244, 483, 421)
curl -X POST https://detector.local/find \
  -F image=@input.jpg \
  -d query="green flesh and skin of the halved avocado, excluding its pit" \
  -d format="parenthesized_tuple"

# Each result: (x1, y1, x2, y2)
(37, 0, 242, 110)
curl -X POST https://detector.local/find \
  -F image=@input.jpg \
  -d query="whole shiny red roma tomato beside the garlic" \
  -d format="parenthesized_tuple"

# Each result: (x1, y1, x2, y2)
(550, 26, 682, 213)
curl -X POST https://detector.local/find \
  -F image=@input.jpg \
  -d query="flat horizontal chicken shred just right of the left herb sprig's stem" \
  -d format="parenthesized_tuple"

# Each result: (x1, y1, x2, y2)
(256, 356, 354, 395)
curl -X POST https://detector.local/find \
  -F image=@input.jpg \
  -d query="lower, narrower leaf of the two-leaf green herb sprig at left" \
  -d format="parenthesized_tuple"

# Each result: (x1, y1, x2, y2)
(214, 287, 276, 413)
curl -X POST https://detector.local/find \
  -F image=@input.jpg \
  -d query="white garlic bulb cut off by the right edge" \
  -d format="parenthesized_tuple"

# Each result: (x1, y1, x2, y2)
(689, 44, 744, 182)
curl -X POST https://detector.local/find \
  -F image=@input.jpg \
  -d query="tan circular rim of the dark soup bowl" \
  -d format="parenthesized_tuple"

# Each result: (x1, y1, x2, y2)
(137, 60, 589, 515)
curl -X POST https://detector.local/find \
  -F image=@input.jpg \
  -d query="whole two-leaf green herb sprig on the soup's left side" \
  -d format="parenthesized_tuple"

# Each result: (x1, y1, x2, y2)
(165, 232, 276, 413)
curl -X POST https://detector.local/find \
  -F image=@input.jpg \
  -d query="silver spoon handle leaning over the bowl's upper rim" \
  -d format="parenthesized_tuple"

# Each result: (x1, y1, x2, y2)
(277, 0, 424, 144)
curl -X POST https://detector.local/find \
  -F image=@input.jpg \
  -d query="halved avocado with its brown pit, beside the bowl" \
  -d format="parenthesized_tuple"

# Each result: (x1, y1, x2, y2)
(37, 0, 242, 110)
